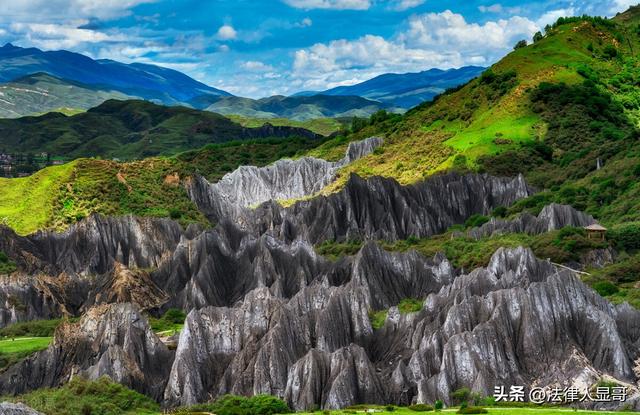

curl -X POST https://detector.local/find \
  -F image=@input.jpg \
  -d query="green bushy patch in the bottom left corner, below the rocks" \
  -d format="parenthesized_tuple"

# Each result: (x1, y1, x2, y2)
(3, 377, 160, 415)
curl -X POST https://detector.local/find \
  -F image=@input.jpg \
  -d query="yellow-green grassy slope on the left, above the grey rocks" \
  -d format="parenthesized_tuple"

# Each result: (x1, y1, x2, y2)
(0, 139, 318, 235)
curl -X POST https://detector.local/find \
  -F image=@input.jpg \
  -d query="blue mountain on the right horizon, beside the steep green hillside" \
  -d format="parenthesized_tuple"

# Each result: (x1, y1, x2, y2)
(295, 66, 485, 109)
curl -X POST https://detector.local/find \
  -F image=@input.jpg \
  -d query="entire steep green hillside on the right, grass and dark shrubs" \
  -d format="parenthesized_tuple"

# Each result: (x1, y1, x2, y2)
(314, 8, 640, 208)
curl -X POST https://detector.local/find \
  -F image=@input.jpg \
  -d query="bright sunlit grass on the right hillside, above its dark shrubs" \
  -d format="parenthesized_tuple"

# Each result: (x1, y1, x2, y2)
(312, 11, 640, 191)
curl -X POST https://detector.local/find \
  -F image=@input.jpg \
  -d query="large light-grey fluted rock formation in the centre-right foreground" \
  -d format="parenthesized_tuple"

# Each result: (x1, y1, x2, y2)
(165, 245, 640, 409)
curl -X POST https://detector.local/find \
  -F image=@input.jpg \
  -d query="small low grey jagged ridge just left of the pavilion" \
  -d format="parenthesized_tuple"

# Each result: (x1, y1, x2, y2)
(467, 203, 596, 239)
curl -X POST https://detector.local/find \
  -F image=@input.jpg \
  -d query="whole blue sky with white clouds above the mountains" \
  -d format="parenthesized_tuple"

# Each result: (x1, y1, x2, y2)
(0, 0, 639, 97)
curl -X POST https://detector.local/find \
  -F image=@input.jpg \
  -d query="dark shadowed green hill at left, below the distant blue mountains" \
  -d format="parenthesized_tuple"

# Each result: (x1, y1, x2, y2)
(0, 100, 313, 160)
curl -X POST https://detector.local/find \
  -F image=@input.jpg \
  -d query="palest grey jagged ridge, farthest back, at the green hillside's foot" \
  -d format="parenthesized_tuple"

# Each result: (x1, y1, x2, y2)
(188, 137, 383, 221)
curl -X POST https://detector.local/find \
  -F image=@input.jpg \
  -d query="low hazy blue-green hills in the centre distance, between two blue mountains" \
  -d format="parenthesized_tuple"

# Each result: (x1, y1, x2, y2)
(206, 95, 397, 121)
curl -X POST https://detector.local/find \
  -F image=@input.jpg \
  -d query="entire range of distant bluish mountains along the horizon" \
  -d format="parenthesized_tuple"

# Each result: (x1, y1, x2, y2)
(0, 43, 483, 121)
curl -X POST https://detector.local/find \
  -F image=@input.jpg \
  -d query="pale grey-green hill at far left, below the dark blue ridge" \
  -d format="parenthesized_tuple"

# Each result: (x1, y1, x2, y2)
(0, 73, 133, 118)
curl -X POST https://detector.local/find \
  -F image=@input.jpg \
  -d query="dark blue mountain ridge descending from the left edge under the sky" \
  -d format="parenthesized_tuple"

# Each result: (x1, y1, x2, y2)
(0, 43, 231, 105)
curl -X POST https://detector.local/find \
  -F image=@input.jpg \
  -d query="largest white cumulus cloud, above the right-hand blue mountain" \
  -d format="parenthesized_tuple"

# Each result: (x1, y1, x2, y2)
(293, 10, 539, 89)
